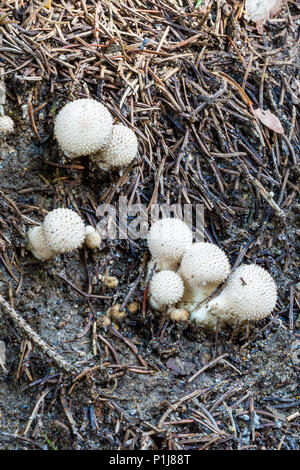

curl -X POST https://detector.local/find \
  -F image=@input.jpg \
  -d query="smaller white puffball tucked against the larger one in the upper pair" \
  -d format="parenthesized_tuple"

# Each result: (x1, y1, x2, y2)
(93, 124, 138, 170)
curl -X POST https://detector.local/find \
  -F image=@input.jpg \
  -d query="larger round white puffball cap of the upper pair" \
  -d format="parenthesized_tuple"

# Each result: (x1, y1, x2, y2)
(54, 99, 113, 158)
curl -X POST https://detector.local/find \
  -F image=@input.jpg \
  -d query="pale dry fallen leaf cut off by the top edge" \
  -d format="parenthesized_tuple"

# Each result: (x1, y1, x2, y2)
(245, 0, 284, 34)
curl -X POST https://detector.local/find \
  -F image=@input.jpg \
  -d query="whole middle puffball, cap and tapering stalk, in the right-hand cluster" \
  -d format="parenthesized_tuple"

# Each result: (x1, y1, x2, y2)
(178, 242, 230, 312)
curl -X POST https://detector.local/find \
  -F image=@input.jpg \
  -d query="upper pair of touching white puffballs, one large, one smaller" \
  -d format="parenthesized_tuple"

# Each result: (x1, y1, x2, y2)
(54, 98, 138, 171)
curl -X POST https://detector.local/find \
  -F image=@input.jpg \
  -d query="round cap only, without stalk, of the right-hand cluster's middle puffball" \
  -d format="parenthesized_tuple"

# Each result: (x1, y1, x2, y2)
(180, 242, 230, 286)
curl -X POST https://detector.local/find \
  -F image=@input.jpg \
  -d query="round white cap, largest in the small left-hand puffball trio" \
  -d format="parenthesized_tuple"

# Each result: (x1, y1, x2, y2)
(43, 209, 85, 253)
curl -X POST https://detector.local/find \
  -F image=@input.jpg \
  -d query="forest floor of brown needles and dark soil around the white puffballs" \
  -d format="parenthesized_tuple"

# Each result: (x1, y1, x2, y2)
(0, 0, 300, 450)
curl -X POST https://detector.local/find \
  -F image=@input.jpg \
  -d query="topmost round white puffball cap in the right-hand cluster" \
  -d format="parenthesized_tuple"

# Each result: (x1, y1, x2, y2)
(147, 217, 193, 263)
